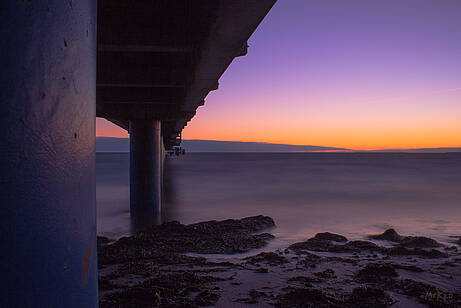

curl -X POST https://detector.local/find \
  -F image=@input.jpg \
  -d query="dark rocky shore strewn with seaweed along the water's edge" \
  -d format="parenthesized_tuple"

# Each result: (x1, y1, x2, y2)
(98, 216, 461, 307)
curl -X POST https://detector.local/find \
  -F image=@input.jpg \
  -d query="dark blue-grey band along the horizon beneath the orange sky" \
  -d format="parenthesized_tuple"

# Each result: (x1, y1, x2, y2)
(96, 137, 461, 153)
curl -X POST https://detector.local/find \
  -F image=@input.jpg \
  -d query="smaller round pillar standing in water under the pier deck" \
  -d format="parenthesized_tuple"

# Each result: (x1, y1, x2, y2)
(130, 120, 162, 225)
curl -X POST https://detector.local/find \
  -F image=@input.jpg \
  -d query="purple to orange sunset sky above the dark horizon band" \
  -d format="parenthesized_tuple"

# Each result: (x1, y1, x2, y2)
(96, 0, 461, 150)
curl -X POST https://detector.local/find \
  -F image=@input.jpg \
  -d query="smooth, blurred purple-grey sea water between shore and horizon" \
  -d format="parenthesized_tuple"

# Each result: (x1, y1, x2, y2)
(96, 153, 461, 245)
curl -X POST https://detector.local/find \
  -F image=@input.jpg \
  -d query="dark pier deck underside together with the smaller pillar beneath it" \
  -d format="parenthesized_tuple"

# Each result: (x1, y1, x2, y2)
(96, 0, 275, 220)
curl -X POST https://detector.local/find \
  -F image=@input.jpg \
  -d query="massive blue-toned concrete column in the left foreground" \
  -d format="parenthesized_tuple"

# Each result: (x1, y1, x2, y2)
(0, 0, 98, 308)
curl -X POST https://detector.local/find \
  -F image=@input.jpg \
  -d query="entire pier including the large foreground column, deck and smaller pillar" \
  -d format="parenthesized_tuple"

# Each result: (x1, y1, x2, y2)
(0, 0, 276, 307)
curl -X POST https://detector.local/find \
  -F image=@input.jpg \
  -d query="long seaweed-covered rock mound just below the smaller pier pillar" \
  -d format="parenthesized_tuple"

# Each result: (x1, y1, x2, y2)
(98, 215, 275, 265)
